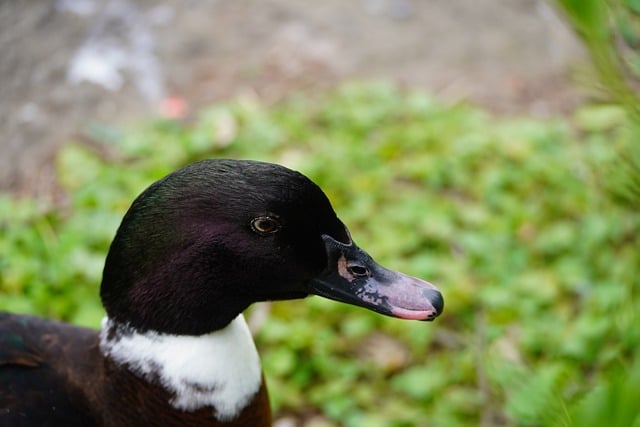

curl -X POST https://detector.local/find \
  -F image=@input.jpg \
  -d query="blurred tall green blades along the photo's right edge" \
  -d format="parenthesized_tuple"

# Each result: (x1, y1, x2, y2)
(554, 0, 640, 426)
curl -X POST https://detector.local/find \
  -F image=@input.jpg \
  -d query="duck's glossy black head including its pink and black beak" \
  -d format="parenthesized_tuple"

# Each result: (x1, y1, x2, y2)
(100, 159, 443, 335)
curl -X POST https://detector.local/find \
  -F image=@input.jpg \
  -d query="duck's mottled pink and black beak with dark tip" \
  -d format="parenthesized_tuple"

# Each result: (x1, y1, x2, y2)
(309, 234, 444, 320)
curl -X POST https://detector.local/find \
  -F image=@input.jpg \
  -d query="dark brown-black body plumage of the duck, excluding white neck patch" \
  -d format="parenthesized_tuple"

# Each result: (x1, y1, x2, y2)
(0, 313, 270, 427)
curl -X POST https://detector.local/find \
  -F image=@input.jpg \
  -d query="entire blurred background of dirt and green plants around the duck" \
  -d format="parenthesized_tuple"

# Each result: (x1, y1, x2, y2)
(0, 0, 640, 427)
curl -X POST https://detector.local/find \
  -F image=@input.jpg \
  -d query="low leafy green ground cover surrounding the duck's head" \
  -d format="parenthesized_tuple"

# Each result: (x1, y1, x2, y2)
(0, 83, 640, 427)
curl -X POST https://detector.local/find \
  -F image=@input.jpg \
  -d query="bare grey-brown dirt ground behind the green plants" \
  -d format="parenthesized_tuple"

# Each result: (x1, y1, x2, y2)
(0, 0, 584, 196)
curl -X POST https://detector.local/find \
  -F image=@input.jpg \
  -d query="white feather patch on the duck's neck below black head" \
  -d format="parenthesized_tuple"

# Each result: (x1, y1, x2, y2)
(100, 314, 262, 421)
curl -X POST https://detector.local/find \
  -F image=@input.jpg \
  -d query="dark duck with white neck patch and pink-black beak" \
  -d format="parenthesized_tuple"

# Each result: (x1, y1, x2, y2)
(0, 159, 444, 427)
